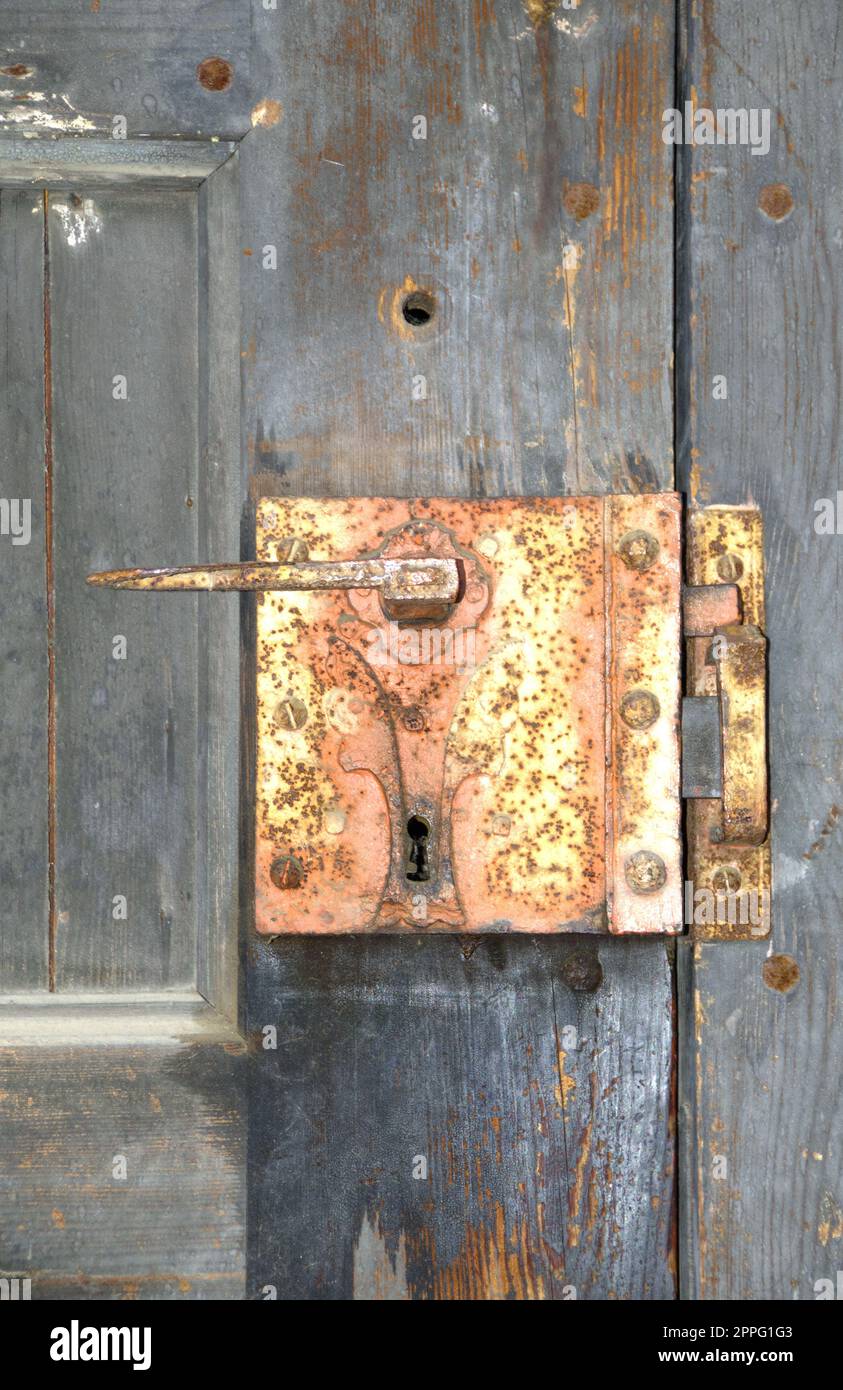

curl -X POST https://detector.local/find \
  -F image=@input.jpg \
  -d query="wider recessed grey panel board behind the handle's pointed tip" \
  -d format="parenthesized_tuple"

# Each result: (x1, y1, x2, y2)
(49, 190, 198, 991)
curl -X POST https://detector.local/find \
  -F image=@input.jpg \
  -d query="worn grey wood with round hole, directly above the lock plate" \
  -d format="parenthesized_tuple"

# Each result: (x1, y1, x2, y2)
(243, 0, 673, 496)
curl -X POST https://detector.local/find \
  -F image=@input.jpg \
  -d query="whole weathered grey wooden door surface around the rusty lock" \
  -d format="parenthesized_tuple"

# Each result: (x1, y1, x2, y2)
(0, 0, 843, 1300)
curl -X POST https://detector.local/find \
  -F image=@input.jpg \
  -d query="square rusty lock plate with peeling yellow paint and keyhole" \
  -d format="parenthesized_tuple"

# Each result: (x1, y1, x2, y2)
(253, 493, 682, 935)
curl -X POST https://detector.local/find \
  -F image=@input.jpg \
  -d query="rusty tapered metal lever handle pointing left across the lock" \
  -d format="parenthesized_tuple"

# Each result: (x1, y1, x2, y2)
(88, 556, 460, 610)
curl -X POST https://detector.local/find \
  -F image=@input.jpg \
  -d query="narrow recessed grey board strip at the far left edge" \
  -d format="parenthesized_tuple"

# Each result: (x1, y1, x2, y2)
(0, 190, 49, 990)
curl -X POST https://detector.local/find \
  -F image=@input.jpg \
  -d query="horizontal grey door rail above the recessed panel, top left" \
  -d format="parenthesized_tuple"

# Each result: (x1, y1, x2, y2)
(0, 0, 253, 139)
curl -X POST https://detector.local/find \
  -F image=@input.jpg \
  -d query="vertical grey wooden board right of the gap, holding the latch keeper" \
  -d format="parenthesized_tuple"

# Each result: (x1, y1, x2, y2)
(677, 0, 843, 1300)
